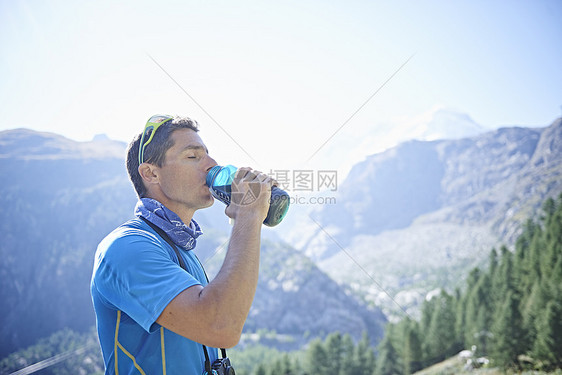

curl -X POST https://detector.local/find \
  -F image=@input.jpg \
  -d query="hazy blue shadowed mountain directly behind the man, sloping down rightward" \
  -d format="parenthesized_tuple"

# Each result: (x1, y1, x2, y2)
(0, 129, 385, 357)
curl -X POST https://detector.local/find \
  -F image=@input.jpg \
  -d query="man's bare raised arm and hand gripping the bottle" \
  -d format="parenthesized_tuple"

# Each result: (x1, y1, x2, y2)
(156, 168, 272, 348)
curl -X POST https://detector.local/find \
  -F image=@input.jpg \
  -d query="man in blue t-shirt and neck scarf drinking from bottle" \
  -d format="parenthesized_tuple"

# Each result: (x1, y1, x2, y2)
(91, 116, 274, 375)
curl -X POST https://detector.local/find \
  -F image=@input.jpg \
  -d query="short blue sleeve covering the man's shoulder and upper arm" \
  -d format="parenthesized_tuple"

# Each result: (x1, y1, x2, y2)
(93, 228, 201, 332)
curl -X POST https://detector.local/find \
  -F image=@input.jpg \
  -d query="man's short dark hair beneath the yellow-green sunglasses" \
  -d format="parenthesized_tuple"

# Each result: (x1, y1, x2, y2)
(127, 116, 199, 198)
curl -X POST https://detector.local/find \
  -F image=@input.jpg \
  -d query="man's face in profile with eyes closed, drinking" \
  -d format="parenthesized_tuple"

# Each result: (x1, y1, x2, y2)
(158, 129, 217, 214)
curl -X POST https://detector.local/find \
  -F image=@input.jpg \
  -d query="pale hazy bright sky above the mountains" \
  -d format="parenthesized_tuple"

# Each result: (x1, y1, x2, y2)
(0, 0, 562, 175)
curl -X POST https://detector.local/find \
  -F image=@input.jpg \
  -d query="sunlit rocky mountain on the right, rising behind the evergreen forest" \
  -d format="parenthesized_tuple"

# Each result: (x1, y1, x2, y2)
(288, 119, 562, 316)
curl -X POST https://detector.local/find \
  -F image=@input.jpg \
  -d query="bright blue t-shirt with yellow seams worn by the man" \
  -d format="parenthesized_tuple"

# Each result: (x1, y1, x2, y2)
(91, 218, 217, 375)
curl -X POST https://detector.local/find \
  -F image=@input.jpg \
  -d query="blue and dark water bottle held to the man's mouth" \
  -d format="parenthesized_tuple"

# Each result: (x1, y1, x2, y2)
(207, 165, 290, 227)
